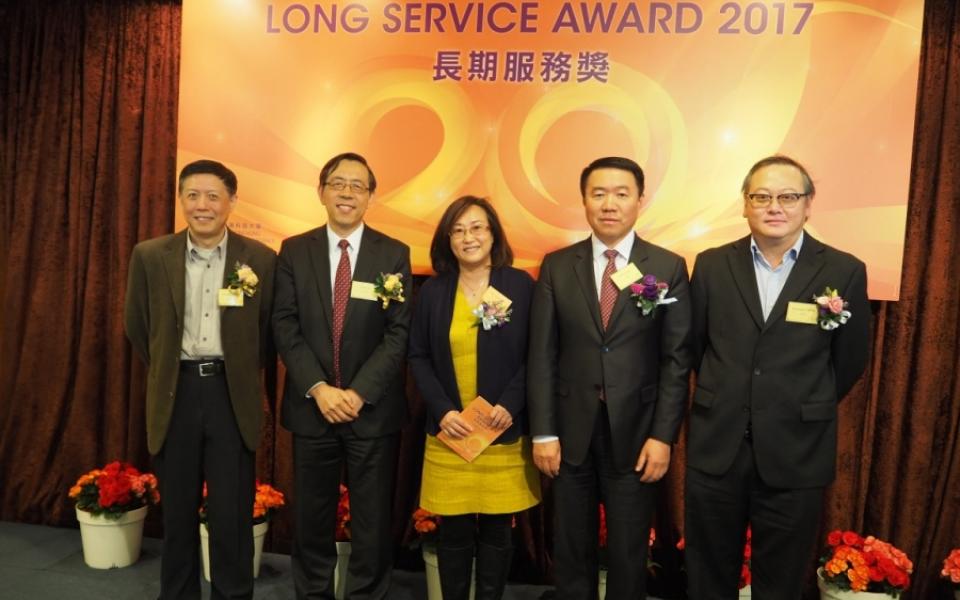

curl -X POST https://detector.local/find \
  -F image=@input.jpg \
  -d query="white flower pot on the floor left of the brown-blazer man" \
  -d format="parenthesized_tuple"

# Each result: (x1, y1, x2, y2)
(76, 506, 147, 569)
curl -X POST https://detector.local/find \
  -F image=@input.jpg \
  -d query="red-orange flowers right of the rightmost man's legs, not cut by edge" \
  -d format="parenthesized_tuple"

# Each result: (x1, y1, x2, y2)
(820, 529, 913, 597)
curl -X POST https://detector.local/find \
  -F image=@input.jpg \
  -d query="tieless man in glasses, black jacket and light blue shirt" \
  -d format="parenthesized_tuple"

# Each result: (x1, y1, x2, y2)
(685, 156, 870, 600)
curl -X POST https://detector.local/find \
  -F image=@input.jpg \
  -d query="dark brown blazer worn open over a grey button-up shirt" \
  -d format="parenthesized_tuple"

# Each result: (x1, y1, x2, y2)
(124, 230, 277, 454)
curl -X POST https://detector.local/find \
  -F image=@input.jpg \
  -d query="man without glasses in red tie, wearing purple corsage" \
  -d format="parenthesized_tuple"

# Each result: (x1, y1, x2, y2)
(527, 157, 690, 600)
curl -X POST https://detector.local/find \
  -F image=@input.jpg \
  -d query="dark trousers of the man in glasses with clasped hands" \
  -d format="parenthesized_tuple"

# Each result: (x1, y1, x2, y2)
(291, 424, 398, 600)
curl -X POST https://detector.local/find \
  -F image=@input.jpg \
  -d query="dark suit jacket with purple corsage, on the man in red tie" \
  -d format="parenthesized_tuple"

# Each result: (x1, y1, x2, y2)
(527, 236, 690, 472)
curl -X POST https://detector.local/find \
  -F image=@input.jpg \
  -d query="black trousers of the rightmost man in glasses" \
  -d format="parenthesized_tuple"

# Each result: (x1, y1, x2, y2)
(684, 439, 823, 600)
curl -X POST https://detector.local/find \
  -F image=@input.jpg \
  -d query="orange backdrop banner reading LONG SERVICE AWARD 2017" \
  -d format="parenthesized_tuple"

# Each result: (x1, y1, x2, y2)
(176, 0, 923, 300)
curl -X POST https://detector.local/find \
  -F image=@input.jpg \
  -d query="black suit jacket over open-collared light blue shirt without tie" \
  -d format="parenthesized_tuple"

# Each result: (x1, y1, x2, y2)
(687, 234, 870, 489)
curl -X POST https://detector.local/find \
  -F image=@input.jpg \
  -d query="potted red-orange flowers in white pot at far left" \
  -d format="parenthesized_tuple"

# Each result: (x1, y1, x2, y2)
(69, 461, 160, 569)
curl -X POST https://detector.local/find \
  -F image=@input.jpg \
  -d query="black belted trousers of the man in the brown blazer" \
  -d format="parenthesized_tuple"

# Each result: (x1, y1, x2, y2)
(154, 369, 255, 600)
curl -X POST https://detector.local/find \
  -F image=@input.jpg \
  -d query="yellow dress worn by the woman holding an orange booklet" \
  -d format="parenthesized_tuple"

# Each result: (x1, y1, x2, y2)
(420, 288, 540, 515)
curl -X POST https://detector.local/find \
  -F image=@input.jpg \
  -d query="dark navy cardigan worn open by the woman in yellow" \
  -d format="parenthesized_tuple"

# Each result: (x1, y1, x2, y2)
(408, 267, 533, 444)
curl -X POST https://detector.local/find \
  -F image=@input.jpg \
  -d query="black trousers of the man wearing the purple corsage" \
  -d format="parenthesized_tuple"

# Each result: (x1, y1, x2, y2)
(554, 405, 656, 600)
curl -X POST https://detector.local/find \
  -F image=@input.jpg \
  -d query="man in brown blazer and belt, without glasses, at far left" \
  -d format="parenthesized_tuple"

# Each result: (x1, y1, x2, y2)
(124, 160, 276, 600)
